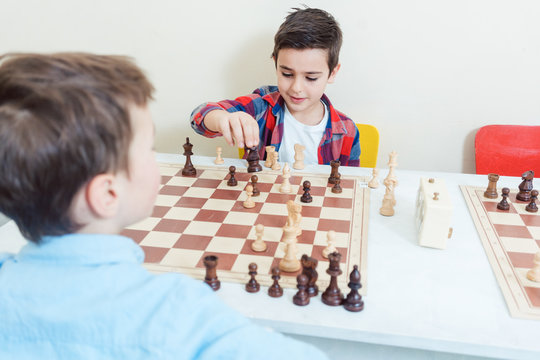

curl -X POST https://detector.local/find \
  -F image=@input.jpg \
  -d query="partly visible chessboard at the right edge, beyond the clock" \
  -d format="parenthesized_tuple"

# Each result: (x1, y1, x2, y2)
(461, 186, 540, 320)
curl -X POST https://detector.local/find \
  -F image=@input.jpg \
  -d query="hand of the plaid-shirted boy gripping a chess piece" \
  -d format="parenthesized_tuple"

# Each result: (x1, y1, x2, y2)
(204, 110, 259, 148)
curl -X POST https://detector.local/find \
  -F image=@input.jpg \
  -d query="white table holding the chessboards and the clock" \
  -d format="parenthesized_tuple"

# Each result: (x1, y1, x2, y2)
(0, 154, 540, 359)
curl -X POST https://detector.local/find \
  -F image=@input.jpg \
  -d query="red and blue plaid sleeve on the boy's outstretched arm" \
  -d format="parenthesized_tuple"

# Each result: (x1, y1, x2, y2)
(190, 93, 266, 138)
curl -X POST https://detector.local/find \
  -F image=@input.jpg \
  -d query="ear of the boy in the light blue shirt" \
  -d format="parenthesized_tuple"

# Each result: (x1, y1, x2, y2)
(86, 174, 119, 218)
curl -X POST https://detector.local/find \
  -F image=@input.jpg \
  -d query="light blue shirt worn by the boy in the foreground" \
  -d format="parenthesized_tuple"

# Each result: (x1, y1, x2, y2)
(0, 234, 325, 359)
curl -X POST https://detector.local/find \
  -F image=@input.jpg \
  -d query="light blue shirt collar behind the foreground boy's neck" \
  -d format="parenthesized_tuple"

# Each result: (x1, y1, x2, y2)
(15, 234, 144, 265)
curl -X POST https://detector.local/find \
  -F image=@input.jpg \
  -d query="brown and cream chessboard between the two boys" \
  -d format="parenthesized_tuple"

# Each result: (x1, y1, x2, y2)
(123, 164, 369, 294)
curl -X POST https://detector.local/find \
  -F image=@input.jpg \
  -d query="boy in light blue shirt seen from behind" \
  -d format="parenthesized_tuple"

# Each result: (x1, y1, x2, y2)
(0, 53, 324, 359)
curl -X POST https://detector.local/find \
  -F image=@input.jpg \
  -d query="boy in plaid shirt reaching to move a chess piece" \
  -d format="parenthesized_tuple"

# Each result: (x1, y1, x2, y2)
(191, 8, 360, 166)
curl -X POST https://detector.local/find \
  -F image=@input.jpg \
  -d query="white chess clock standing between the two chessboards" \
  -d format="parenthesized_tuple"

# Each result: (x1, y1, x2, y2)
(415, 178, 452, 249)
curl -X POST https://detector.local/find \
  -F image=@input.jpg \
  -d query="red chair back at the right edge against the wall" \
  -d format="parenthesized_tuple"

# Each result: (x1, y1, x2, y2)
(474, 125, 540, 176)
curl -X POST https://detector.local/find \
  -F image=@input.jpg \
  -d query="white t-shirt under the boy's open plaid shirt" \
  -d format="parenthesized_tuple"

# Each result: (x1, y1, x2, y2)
(278, 102, 328, 165)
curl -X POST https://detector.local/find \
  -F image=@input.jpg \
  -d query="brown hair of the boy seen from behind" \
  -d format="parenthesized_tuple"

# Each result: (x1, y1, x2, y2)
(0, 53, 154, 243)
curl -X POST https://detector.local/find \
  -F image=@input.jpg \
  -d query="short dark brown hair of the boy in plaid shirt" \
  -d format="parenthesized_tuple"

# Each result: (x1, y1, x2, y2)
(272, 8, 343, 74)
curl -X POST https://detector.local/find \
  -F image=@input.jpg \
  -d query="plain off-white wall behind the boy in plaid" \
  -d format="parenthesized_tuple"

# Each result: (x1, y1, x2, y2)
(0, 0, 540, 172)
